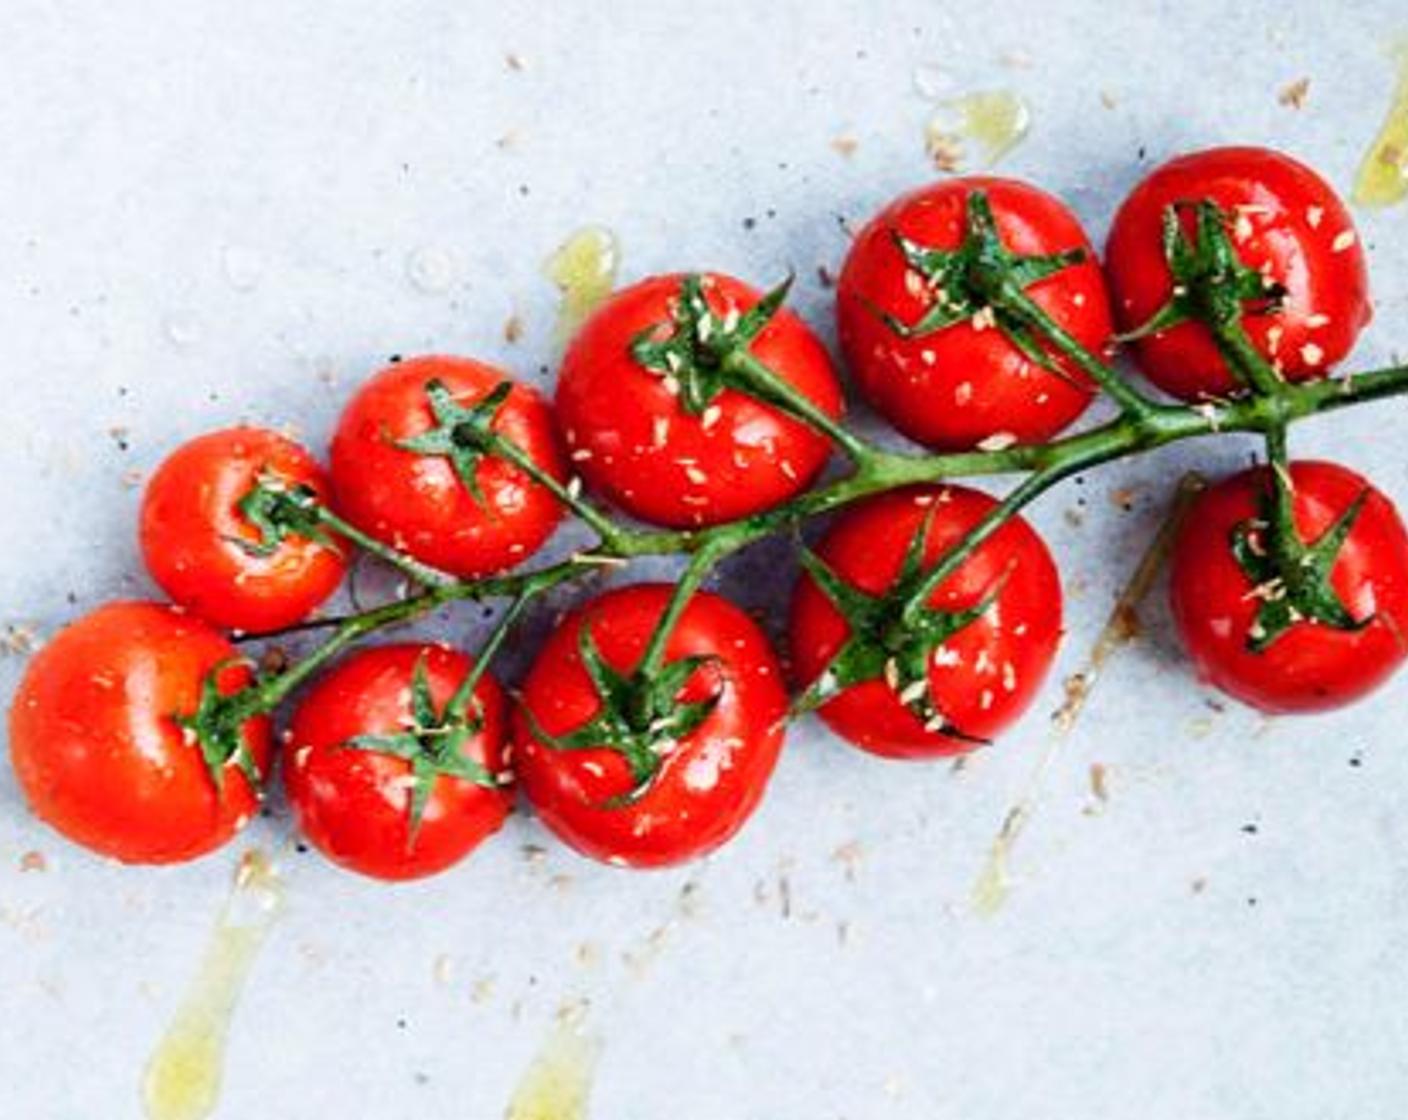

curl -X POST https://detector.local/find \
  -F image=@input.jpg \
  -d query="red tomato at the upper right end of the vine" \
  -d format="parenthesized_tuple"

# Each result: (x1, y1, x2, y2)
(1105, 148, 1371, 400)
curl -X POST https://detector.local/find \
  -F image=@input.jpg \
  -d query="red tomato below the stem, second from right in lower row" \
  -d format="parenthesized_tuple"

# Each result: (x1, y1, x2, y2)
(790, 486, 1062, 758)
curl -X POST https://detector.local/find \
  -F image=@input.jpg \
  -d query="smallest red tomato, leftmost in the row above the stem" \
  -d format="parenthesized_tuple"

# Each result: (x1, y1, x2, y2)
(141, 428, 346, 633)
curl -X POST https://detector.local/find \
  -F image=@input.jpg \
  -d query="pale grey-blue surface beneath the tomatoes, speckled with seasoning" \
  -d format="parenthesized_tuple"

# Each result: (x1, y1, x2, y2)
(0, 0, 1408, 1120)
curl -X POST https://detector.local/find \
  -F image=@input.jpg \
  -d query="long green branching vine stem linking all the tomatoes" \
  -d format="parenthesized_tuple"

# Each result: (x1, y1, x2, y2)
(187, 193, 1408, 783)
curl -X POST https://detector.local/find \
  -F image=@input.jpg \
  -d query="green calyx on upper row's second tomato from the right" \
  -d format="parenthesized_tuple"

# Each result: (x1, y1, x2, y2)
(872, 190, 1086, 376)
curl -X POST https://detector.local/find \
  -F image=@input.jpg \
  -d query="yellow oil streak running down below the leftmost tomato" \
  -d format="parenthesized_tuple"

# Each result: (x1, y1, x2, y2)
(142, 851, 283, 1120)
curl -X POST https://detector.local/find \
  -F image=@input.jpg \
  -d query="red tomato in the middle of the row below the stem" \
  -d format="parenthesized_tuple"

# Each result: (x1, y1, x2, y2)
(514, 583, 787, 866)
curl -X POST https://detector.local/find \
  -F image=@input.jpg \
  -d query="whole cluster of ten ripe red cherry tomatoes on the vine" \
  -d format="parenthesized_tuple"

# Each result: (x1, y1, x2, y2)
(10, 149, 1408, 878)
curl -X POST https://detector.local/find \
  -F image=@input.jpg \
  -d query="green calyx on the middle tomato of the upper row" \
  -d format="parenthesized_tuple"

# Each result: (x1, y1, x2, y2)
(631, 273, 793, 416)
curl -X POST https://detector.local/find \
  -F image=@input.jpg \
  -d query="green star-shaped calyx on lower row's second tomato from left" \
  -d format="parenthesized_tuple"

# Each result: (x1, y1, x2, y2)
(342, 652, 505, 845)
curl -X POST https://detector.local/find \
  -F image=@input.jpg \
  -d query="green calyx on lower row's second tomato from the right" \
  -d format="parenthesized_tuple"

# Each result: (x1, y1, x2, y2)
(794, 510, 1007, 744)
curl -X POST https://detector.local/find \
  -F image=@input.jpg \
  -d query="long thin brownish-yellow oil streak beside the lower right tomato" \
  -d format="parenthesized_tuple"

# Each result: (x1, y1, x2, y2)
(970, 475, 1207, 917)
